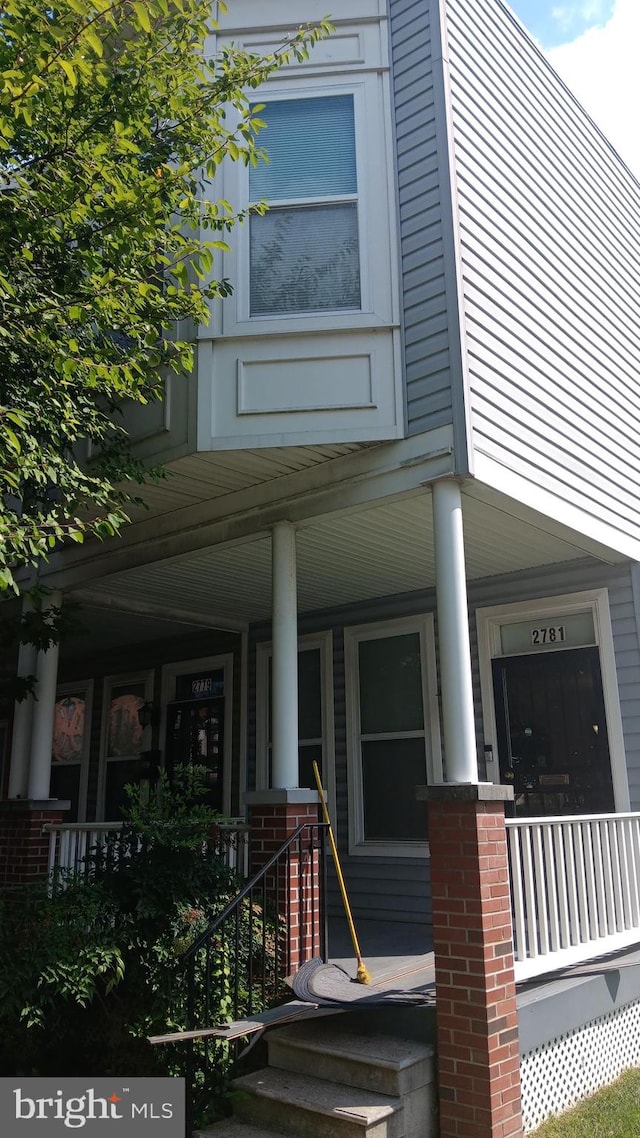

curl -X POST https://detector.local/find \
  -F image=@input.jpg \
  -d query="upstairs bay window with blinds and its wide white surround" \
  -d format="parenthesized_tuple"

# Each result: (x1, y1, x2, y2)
(211, 21, 400, 336)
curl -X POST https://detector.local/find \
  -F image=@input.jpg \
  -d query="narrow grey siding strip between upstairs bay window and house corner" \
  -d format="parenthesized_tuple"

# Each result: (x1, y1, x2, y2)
(389, 0, 452, 435)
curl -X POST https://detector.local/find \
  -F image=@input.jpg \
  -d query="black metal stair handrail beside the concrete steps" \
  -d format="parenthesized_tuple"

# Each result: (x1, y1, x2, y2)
(179, 822, 327, 1132)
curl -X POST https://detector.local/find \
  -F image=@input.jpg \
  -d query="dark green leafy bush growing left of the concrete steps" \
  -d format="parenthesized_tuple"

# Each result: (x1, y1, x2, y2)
(0, 767, 274, 1092)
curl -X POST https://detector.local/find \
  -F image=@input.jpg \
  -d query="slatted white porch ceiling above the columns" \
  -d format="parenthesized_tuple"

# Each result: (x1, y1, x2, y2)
(72, 490, 585, 624)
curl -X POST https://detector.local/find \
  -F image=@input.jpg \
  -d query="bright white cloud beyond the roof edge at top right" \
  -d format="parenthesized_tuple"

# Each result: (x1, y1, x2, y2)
(547, 0, 640, 178)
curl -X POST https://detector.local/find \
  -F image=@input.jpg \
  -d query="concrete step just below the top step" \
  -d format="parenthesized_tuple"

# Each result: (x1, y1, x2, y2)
(228, 1067, 404, 1138)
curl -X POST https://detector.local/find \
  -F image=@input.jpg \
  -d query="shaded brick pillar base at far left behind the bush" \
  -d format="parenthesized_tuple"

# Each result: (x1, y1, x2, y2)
(0, 798, 71, 894)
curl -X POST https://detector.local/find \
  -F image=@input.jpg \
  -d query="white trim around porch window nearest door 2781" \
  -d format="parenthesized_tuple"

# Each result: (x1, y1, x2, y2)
(344, 612, 443, 858)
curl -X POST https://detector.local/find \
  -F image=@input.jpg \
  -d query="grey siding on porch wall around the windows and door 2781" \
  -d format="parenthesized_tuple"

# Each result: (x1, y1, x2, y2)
(249, 559, 640, 922)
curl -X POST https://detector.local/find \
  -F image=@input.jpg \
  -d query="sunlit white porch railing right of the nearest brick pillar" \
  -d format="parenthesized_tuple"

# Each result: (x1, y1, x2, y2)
(507, 814, 640, 980)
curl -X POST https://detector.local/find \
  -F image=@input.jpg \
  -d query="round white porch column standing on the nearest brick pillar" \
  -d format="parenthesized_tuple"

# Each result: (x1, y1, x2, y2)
(433, 478, 478, 783)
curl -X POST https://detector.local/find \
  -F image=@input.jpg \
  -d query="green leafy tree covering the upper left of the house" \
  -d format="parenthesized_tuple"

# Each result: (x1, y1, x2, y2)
(0, 0, 330, 591)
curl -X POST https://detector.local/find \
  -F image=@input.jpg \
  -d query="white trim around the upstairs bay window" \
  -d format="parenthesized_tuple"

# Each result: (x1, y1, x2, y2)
(216, 72, 399, 336)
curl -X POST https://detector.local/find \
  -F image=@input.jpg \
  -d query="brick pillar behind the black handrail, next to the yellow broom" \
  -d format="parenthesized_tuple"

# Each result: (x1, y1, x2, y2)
(245, 789, 325, 976)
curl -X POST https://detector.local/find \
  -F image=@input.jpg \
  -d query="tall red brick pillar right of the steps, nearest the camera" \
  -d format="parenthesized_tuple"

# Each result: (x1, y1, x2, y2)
(418, 783, 523, 1138)
